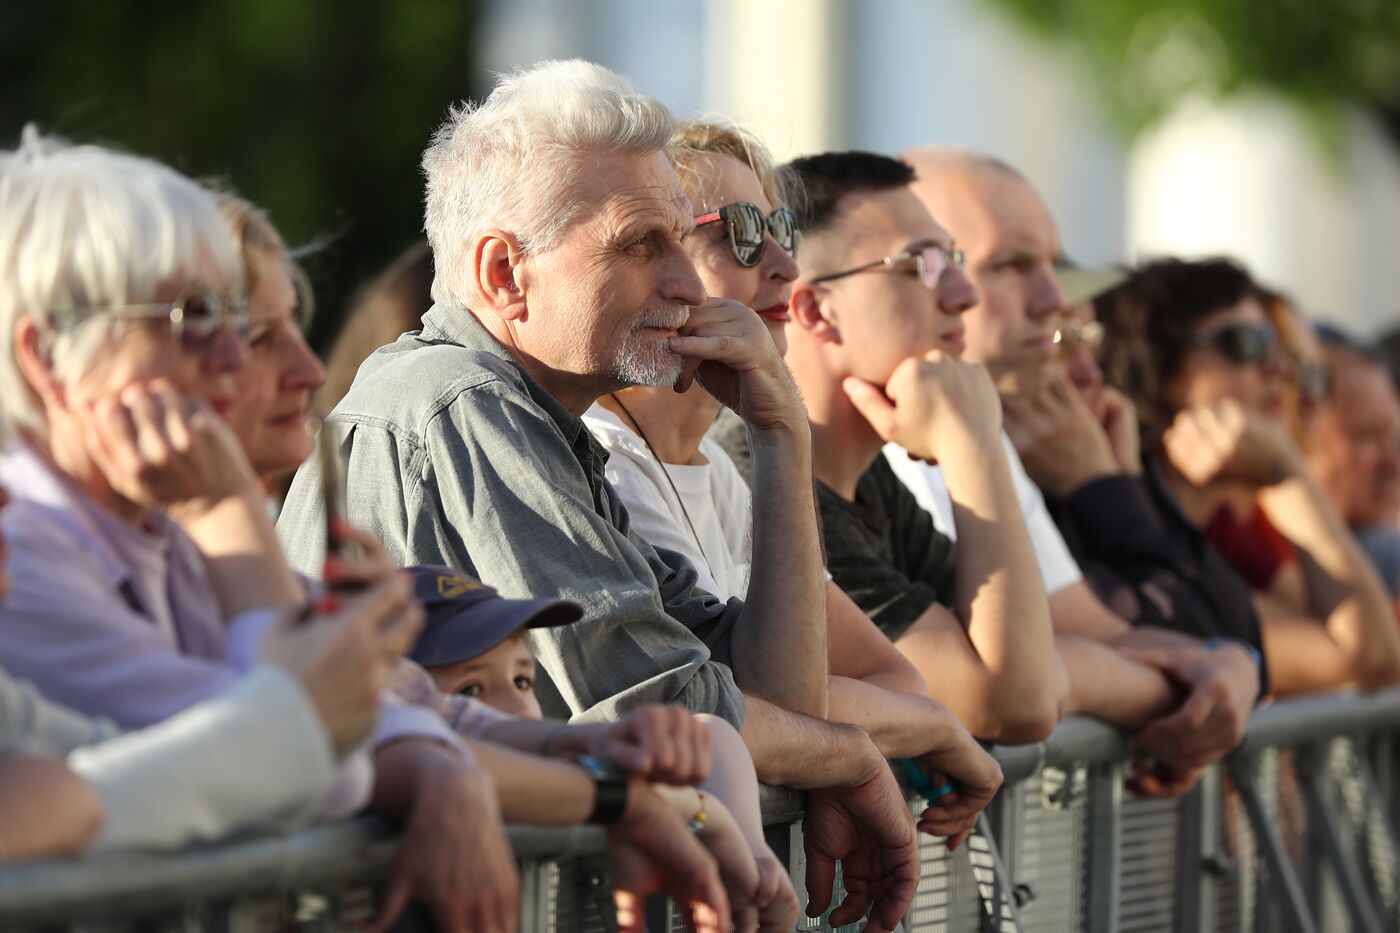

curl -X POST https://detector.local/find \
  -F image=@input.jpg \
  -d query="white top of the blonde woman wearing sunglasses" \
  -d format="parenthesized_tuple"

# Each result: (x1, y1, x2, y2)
(584, 405, 753, 600)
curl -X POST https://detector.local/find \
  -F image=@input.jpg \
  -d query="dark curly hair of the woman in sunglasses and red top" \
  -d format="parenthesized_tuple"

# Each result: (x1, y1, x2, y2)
(1093, 258, 1257, 451)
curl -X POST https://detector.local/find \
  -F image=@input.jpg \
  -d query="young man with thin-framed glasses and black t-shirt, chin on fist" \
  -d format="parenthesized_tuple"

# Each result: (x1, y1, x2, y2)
(725, 153, 1170, 742)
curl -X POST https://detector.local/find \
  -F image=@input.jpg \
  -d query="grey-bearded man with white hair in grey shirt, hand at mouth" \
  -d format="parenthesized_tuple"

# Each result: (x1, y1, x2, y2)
(280, 62, 917, 929)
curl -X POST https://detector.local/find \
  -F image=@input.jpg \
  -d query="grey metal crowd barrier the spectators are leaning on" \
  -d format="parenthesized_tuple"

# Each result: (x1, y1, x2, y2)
(0, 688, 1400, 933)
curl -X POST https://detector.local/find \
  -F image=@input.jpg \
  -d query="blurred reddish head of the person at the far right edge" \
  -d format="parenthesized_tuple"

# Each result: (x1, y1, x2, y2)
(1308, 340, 1400, 597)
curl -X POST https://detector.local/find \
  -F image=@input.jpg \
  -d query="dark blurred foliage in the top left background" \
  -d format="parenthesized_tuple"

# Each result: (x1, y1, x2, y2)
(0, 0, 476, 349)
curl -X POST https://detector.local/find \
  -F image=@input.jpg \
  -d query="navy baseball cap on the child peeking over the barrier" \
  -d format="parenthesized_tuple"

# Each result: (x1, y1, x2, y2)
(409, 566, 584, 667)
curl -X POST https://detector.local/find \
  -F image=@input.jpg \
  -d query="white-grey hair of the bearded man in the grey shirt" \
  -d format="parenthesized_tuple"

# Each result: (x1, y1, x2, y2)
(423, 59, 675, 305)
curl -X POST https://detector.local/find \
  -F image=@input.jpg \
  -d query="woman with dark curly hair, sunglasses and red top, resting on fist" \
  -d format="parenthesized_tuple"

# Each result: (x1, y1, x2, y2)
(1096, 259, 1400, 695)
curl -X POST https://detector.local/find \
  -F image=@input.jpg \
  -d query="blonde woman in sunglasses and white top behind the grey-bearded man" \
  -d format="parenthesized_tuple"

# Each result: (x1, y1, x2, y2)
(584, 122, 998, 846)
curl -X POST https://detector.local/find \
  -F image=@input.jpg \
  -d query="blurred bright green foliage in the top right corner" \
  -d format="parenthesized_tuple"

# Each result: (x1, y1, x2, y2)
(983, 0, 1400, 146)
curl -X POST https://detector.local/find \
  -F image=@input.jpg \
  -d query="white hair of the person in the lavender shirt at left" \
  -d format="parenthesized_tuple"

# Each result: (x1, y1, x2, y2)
(0, 126, 242, 439)
